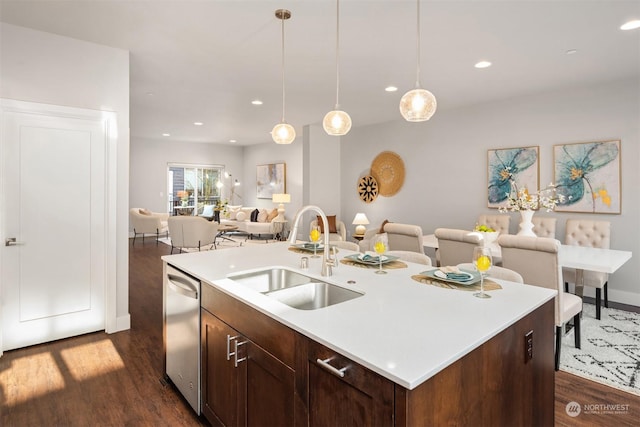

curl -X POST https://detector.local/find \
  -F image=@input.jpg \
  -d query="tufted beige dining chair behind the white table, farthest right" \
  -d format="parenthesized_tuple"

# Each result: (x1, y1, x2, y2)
(562, 219, 611, 320)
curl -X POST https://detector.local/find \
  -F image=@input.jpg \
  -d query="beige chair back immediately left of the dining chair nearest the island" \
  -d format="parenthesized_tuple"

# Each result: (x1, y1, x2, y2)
(435, 228, 484, 266)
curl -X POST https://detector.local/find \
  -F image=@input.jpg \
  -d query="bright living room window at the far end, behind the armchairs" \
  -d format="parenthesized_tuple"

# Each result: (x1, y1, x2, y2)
(167, 163, 224, 215)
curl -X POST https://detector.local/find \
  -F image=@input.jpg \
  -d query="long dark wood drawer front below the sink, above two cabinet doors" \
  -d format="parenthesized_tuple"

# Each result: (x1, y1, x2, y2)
(202, 283, 295, 367)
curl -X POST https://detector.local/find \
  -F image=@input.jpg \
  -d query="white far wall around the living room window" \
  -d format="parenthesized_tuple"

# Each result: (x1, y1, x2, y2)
(129, 138, 244, 216)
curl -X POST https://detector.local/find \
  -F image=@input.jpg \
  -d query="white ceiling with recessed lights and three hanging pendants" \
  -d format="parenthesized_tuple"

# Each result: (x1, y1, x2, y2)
(0, 0, 640, 145)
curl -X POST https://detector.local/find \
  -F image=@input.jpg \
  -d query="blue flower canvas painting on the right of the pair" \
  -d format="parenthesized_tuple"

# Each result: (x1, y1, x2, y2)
(553, 140, 622, 214)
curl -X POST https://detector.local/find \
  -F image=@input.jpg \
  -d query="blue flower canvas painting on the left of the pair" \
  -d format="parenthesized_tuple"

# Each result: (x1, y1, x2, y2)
(487, 146, 540, 208)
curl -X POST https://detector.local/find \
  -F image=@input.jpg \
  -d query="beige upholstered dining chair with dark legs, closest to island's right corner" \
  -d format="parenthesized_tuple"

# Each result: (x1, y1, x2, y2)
(498, 235, 582, 371)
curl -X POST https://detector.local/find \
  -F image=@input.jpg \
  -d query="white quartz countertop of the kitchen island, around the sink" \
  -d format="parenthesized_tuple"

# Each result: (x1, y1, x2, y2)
(163, 242, 556, 389)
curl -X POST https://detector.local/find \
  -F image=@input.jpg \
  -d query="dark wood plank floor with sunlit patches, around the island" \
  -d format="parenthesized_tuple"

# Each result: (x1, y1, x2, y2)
(0, 239, 640, 427)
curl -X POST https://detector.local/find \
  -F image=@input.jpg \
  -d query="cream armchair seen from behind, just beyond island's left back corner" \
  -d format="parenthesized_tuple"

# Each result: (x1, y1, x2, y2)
(169, 216, 218, 253)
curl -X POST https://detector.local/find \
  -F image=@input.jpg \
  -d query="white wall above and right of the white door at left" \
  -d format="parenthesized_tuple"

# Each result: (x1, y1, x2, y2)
(0, 23, 129, 330)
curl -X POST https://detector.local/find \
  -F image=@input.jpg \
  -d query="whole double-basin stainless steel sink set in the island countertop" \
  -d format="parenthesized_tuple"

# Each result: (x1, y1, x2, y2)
(228, 267, 364, 310)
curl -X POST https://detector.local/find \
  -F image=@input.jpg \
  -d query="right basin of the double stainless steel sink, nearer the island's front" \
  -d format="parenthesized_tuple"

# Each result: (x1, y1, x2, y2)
(265, 282, 364, 310)
